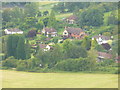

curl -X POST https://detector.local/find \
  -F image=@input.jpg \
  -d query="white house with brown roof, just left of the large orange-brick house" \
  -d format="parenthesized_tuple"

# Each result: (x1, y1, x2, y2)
(42, 28, 57, 37)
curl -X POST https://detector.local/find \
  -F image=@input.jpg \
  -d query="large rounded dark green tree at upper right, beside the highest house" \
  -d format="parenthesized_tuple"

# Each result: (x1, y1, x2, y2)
(79, 8, 103, 26)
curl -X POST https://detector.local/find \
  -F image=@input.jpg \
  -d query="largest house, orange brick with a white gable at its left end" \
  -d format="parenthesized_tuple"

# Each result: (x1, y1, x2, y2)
(63, 27, 87, 39)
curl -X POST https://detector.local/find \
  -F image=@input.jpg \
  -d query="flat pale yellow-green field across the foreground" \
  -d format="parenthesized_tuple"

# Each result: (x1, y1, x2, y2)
(0, 70, 118, 88)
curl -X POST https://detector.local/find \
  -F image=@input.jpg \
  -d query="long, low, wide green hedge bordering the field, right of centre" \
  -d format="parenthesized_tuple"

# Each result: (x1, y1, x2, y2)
(55, 58, 91, 71)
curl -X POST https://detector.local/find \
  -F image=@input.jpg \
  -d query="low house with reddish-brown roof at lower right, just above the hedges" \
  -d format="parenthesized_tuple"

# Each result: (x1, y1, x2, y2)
(98, 52, 113, 62)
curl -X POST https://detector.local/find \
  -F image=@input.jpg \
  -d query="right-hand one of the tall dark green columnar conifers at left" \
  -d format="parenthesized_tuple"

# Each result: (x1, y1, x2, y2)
(16, 36, 26, 59)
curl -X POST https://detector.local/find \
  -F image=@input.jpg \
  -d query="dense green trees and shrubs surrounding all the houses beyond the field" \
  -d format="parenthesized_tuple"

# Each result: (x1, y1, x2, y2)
(1, 2, 119, 73)
